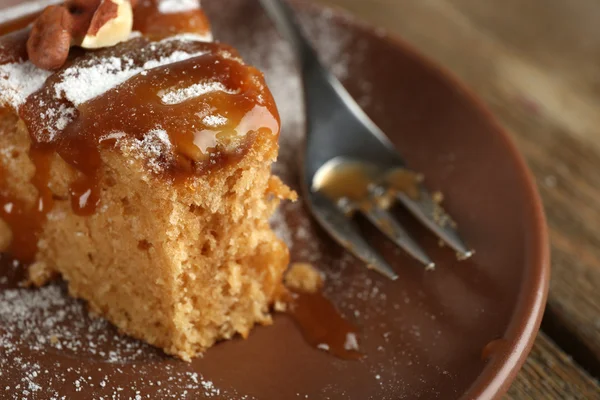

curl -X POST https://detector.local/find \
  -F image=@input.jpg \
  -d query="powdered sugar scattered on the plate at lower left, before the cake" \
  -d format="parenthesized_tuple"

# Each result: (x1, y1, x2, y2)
(0, 260, 237, 400)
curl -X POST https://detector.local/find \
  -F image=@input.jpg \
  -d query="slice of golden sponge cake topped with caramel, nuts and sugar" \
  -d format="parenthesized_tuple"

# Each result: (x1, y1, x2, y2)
(0, 0, 295, 360)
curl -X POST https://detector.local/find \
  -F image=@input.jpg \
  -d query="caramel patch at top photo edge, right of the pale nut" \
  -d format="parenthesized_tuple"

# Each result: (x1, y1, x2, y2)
(133, 0, 210, 39)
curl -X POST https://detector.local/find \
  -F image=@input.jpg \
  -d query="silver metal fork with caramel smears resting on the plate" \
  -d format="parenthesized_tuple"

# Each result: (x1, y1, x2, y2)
(260, 0, 473, 280)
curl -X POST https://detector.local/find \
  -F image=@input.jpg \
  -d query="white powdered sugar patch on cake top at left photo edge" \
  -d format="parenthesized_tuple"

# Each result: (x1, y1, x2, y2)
(0, 61, 52, 110)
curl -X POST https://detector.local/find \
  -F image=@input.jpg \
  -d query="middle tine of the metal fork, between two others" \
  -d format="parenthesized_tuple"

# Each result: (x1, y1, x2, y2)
(361, 206, 435, 269)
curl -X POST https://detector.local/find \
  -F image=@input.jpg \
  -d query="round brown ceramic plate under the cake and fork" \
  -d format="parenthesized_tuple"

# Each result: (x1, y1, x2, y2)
(0, 0, 548, 400)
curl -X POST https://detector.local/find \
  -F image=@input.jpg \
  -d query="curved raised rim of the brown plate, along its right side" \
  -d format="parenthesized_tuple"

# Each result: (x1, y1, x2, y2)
(291, 0, 551, 400)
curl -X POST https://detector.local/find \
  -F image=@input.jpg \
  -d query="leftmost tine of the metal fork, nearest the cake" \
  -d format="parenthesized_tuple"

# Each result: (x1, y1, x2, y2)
(308, 192, 398, 281)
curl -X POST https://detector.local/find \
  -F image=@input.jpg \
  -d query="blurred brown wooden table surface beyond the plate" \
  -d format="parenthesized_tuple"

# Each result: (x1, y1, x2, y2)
(319, 0, 600, 400)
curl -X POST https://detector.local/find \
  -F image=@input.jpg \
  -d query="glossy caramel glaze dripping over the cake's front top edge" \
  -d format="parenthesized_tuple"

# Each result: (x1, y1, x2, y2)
(20, 39, 279, 215)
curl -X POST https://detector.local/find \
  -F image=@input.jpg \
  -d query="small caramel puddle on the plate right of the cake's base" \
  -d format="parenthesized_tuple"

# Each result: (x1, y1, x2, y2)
(288, 292, 362, 360)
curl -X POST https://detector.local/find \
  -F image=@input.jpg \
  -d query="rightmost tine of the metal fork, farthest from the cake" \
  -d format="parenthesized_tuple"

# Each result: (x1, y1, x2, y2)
(396, 185, 475, 260)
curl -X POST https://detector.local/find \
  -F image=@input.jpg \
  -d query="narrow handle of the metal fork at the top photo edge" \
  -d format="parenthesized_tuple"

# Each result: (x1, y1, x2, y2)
(260, 0, 321, 70)
